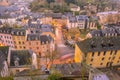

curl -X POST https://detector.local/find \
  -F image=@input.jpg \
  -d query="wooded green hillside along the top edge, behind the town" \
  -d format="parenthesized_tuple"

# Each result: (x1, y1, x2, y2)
(30, 0, 119, 13)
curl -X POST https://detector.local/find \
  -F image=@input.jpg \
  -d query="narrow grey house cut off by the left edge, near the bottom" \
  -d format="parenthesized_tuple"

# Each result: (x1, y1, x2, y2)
(0, 50, 9, 77)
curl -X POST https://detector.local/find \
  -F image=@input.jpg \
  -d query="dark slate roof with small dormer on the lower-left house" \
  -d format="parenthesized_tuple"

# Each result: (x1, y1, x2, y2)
(10, 50, 32, 67)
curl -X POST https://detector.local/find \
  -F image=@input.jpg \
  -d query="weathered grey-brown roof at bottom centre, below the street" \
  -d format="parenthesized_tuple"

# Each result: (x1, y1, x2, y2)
(50, 63, 89, 77)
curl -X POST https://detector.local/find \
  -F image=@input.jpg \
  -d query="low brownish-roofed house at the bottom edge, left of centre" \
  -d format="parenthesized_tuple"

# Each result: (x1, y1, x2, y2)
(14, 69, 49, 80)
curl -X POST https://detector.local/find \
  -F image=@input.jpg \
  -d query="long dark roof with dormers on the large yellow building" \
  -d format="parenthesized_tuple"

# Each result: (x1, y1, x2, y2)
(76, 37, 120, 53)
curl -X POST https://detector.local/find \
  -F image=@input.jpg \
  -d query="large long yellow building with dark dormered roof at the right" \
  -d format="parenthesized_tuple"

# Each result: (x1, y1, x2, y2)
(74, 37, 120, 68)
